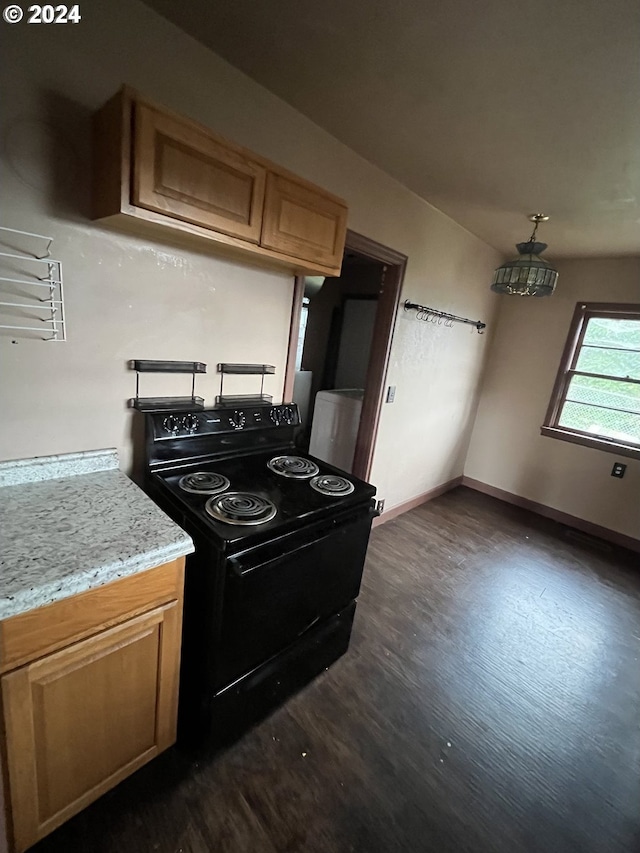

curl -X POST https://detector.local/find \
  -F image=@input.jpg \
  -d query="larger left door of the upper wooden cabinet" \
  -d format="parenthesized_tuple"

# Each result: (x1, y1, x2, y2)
(132, 104, 266, 243)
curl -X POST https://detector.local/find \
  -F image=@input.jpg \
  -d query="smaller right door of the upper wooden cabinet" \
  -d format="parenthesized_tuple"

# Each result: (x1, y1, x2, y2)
(260, 172, 347, 267)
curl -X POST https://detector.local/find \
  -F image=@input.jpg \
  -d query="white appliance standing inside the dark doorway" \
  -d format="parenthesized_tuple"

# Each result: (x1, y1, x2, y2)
(309, 388, 364, 472)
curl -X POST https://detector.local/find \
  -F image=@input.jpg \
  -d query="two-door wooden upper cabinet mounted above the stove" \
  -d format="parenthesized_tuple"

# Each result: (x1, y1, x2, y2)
(93, 87, 347, 275)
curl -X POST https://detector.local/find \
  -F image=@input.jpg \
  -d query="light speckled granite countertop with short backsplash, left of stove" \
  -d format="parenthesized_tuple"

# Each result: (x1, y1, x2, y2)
(0, 450, 194, 619)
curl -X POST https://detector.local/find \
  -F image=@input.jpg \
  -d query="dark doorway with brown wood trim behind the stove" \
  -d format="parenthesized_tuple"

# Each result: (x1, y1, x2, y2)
(284, 231, 407, 480)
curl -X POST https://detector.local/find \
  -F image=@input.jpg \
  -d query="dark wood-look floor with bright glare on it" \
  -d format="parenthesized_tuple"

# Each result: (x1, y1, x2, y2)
(33, 488, 640, 853)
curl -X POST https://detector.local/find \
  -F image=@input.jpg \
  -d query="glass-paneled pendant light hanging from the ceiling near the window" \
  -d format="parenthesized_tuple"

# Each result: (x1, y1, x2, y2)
(491, 213, 558, 296)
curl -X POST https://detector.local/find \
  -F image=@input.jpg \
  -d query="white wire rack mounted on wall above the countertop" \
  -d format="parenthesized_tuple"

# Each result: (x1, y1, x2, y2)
(0, 226, 67, 341)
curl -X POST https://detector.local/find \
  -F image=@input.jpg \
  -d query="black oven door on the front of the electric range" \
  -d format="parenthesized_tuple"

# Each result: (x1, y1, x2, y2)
(218, 505, 375, 689)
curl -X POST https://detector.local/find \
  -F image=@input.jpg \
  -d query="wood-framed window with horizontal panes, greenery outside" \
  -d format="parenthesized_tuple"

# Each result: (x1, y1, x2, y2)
(541, 302, 640, 457)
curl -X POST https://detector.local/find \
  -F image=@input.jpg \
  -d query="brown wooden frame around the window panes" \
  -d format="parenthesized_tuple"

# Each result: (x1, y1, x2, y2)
(540, 302, 640, 459)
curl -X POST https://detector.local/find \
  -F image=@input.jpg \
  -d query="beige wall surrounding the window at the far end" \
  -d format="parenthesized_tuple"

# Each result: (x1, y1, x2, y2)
(465, 258, 640, 538)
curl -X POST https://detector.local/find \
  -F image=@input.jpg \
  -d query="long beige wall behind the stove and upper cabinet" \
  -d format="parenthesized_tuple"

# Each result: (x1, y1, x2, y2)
(0, 0, 499, 507)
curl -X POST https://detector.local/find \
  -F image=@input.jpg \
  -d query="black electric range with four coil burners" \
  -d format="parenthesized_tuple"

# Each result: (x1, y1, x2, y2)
(145, 405, 375, 743)
